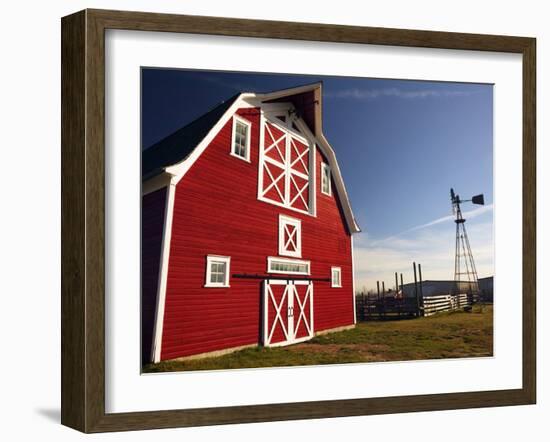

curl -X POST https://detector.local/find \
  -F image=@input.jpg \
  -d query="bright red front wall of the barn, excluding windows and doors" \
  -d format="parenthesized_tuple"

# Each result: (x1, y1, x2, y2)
(161, 109, 354, 360)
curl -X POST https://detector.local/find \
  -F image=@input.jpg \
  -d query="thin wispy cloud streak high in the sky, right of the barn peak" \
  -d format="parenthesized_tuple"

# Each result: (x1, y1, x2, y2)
(325, 87, 472, 100)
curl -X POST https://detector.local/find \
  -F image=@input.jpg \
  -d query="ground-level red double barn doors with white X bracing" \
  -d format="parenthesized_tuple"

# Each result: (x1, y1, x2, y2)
(263, 279, 313, 347)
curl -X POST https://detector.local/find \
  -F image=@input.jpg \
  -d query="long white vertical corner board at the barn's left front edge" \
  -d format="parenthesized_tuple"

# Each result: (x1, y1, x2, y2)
(151, 180, 176, 362)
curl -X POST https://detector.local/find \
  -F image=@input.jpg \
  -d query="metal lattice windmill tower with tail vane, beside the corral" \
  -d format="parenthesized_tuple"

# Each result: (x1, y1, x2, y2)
(451, 188, 485, 296)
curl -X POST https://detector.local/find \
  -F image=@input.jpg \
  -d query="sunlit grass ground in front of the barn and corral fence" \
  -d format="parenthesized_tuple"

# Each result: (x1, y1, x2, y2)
(144, 306, 493, 373)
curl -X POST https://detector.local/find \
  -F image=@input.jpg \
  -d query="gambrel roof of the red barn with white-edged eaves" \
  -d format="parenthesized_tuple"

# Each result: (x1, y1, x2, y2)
(142, 83, 361, 233)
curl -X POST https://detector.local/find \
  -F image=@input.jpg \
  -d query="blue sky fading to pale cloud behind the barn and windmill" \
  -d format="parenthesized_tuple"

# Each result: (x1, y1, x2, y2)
(142, 69, 493, 288)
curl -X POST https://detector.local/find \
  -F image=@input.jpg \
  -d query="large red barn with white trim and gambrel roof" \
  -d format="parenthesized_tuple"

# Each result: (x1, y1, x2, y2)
(142, 83, 359, 362)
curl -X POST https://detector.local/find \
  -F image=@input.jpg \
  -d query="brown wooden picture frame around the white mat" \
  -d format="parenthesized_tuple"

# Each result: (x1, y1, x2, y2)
(61, 9, 536, 433)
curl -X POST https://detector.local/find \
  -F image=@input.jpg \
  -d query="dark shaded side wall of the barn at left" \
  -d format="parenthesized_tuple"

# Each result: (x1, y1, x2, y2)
(141, 188, 166, 362)
